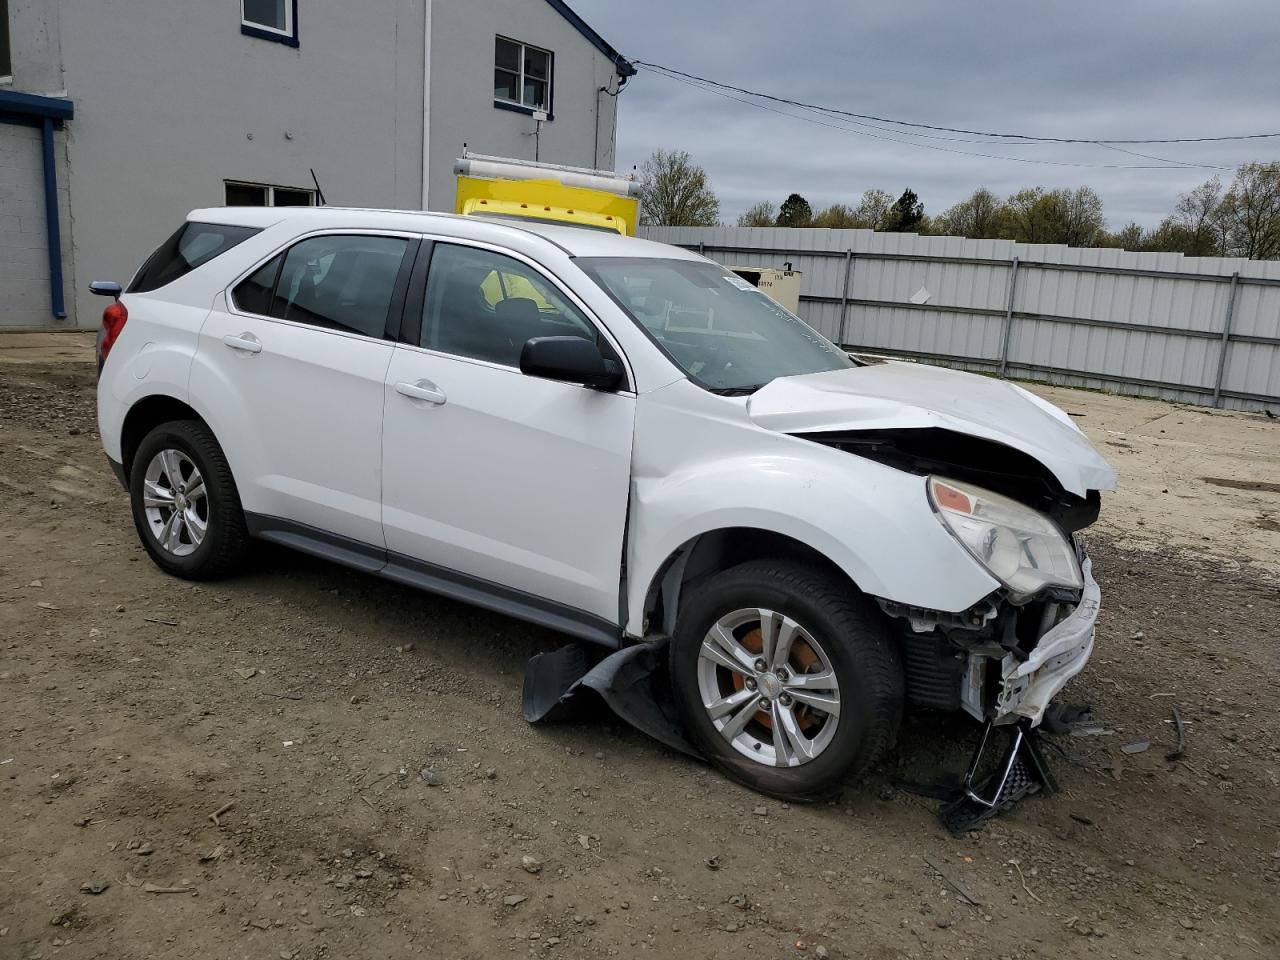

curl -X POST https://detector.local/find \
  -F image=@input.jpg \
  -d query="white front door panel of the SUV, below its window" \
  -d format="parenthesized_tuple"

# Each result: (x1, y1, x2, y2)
(383, 347, 635, 623)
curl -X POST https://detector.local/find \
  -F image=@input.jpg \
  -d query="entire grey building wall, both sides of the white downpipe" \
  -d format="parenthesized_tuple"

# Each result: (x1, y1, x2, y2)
(0, 0, 617, 328)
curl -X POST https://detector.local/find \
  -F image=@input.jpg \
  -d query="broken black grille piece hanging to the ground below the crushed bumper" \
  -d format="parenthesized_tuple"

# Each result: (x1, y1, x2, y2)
(938, 719, 1057, 837)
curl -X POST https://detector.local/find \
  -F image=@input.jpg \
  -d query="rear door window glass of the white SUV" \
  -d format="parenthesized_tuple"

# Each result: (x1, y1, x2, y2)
(266, 236, 408, 337)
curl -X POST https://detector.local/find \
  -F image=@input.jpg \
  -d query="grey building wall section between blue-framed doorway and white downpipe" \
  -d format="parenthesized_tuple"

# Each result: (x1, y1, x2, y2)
(61, 0, 424, 325)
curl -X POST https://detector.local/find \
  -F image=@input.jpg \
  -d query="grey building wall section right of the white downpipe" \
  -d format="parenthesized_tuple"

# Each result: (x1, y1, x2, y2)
(429, 0, 618, 210)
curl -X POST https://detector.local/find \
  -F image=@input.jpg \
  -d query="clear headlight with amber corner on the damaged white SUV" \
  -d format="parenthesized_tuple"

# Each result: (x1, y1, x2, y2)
(928, 476, 1084, 596)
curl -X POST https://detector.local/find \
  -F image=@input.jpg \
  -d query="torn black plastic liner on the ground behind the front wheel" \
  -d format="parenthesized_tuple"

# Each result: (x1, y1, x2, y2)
(521, 647, 701, 758)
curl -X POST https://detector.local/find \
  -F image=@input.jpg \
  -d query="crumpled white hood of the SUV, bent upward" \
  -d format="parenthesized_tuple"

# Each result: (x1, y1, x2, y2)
(746, 361, 1116, 497)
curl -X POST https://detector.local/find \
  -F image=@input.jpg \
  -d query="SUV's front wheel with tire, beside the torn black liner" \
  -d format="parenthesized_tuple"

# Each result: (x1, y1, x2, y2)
(671, 561, 905, 803)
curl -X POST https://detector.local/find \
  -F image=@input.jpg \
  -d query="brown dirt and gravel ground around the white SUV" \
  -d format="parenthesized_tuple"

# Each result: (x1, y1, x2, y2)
(0, 337, 1280, 960)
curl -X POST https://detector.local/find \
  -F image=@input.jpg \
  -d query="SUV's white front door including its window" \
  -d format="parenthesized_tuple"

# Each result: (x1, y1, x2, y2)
(383, 242, 635, 636)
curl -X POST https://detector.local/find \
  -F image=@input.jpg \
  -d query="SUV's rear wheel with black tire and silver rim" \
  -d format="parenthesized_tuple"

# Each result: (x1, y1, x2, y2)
(129, 420, 250, 580)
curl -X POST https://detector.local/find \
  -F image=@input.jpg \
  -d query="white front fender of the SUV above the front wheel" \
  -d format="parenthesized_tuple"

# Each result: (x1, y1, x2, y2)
(626, 380, 1000, 636)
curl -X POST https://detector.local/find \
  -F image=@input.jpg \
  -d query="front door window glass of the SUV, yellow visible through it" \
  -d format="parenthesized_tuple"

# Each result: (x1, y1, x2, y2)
(421, 243, 596, 366)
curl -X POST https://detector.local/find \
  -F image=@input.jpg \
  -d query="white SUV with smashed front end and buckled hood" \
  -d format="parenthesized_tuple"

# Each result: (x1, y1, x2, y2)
(92, 207, 1115, 799)
